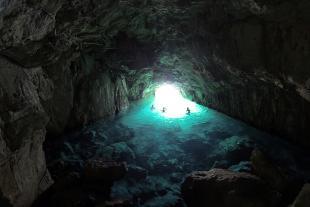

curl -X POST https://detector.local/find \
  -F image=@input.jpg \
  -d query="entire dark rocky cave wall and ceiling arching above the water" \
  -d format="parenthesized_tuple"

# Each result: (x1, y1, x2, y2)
(0, 0, 310, 206)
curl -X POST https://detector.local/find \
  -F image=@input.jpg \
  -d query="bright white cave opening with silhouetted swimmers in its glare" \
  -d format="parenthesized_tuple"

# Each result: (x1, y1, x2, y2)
(154, 84, 199, 118)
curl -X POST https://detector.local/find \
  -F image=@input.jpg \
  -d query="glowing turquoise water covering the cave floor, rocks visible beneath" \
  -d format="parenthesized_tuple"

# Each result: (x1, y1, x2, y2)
(46, 99, 310, 206)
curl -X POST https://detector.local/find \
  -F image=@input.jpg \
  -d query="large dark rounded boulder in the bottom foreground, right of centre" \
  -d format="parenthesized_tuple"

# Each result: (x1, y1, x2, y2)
(182, 169, 277, 207)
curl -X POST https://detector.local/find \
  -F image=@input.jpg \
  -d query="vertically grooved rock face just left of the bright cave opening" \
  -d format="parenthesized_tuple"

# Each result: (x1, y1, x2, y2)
(74, 73, 129, 124)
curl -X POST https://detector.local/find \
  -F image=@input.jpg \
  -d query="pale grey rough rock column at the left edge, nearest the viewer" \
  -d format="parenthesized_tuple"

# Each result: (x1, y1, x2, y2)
(0, 55, 52, 207)
